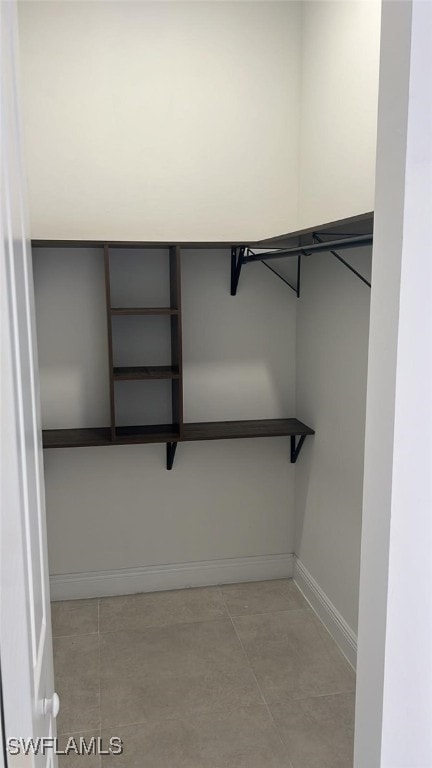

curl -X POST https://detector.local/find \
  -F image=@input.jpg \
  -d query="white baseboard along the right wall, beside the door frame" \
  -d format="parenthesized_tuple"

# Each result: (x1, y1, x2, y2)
(294, 557, 357, 669)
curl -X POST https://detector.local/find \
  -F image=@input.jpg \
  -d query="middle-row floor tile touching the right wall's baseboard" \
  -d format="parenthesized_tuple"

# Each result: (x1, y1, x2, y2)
(233, 610, 355, 703)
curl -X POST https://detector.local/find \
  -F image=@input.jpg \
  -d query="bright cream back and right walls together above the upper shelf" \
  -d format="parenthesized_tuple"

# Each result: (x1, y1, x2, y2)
(19, 0, 380, 240)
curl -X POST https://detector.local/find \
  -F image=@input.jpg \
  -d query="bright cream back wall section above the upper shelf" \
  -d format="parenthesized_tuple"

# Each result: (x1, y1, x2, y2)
(16, 1, 300, 241)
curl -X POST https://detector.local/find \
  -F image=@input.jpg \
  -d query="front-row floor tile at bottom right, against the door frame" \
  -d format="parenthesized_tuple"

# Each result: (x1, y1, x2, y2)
(271, 693, 355, 768)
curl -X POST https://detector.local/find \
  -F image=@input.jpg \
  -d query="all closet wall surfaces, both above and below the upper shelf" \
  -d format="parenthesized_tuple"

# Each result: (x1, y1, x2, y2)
(24, 0, 379, 627)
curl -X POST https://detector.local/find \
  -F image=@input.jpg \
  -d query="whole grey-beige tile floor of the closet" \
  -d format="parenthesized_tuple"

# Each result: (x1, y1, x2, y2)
(52, 580, 355, 768)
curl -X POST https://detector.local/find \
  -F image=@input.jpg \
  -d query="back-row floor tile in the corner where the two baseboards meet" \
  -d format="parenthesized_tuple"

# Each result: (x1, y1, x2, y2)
(221, 579, 307, 616)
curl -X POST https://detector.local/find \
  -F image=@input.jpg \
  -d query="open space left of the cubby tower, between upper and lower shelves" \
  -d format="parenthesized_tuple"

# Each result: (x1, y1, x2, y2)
(32, 245, 109, 446)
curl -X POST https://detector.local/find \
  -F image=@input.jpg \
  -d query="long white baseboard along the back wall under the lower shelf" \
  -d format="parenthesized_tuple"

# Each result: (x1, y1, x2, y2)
(50, 554, 294, 600)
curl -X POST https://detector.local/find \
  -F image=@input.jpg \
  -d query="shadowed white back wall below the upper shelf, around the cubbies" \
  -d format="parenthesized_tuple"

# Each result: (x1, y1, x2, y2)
(34, 249, 296, 573)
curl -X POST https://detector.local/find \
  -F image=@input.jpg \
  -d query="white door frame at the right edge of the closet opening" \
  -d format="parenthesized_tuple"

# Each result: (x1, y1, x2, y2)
(354, 0, 432, 768)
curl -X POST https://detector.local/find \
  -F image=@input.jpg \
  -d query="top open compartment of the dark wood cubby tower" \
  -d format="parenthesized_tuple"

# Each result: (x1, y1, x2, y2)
(109, 247, 178, 315)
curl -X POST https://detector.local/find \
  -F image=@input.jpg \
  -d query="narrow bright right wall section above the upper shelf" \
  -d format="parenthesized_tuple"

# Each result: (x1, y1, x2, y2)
(298, 0, 381, 231)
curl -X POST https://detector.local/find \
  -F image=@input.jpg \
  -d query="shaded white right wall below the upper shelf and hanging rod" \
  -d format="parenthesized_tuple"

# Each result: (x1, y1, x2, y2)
(295, 248, 371, 632)
